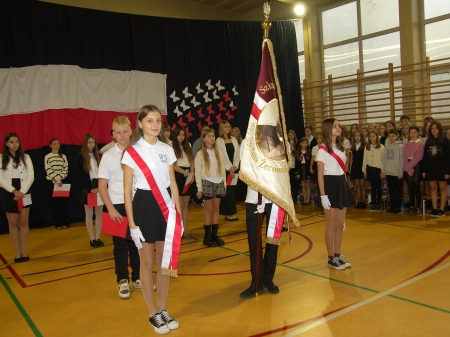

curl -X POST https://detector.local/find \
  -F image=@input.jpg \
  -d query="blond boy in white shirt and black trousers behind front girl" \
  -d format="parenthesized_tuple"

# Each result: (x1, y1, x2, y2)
(98, 116, 141, 298)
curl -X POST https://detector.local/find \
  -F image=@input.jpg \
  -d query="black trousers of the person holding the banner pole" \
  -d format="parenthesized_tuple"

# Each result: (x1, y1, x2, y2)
(245, 203, 278, 289)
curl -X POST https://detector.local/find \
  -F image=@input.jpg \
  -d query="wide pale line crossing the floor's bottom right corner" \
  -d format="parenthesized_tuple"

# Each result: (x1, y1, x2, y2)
(285, 262, 450, 337)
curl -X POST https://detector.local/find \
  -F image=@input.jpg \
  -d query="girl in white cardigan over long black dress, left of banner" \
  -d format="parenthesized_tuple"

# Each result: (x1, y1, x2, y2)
(216, 121, 241, 221)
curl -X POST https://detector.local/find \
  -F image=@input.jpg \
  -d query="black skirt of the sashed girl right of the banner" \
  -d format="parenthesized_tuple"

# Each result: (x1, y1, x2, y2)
(323, 175, 355, 209)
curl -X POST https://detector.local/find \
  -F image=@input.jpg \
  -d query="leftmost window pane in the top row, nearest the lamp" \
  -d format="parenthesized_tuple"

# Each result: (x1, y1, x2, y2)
(322, 2, 358, 45)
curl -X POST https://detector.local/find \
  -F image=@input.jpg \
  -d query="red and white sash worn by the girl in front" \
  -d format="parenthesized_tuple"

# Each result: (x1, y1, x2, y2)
(125, 144, 183, 277)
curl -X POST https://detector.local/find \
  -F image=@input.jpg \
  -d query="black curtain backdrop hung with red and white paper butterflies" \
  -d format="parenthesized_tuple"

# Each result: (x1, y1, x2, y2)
(0, 0, 303, 232)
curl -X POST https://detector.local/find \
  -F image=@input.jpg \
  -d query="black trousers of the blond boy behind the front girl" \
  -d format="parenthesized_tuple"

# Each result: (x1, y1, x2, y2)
(103, 204, 141, 283)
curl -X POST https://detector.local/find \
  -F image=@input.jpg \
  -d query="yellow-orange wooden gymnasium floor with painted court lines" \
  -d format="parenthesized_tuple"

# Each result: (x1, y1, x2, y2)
(0, 204, 450, 337)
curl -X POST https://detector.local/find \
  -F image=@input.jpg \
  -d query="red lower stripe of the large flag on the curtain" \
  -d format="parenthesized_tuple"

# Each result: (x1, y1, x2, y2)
(0, 108, 137, 150)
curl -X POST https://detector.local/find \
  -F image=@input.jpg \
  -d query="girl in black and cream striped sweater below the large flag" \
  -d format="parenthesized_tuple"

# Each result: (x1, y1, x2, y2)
(44, 138, 70, 229)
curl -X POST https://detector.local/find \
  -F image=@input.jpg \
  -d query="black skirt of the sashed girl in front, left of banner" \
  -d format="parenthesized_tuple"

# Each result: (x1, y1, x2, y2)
(133, 188, 171, 243)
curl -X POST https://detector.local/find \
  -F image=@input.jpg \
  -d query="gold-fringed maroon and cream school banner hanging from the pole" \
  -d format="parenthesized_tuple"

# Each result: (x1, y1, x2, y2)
(239, 39, 299, 244)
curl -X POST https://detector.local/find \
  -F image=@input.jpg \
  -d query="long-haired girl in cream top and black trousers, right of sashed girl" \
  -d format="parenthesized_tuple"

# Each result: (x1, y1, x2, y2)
(362, 131, 385, 211)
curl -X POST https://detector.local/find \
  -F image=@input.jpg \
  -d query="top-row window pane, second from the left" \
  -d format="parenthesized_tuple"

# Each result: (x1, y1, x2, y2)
(360, 0, 399, 35)
